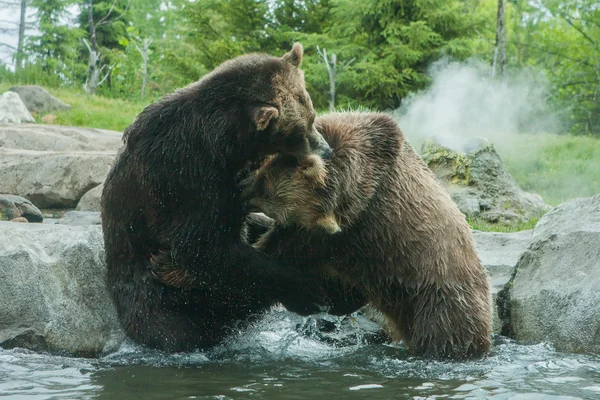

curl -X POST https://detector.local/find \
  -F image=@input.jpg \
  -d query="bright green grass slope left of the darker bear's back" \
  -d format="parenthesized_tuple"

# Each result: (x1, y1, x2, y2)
(0, 83, 145, 132)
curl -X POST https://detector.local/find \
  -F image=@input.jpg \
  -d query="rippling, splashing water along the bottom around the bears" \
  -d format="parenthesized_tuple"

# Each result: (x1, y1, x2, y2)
(0, 310, 600, 400)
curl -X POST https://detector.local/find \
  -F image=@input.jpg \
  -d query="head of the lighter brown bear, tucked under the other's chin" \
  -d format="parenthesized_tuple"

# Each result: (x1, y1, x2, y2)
(241, 155, 341, 234)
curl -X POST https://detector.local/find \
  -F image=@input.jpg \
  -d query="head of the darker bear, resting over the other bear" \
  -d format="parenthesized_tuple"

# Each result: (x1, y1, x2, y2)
(209, 43, 331, 160)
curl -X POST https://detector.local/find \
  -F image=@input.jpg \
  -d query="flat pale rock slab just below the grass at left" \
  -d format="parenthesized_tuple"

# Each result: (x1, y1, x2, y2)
(0, 123, 122, 153)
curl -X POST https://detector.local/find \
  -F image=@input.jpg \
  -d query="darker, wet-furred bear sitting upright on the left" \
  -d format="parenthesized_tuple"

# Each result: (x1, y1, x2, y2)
(102, 44, 331, 351)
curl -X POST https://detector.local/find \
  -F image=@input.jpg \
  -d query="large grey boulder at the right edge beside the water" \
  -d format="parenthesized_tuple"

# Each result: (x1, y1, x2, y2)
(504, 195, 600, 354)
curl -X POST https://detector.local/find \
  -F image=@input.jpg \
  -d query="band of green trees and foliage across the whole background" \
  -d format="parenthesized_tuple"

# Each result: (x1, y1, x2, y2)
(0, 0, 600, 136)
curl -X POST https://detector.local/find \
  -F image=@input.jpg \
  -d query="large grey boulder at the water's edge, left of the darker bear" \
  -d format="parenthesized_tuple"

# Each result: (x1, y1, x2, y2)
(0, 222, 124, 357)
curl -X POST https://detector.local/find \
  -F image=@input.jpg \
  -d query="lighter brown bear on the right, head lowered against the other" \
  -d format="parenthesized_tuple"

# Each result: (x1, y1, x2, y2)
(243, 113, 491, 359)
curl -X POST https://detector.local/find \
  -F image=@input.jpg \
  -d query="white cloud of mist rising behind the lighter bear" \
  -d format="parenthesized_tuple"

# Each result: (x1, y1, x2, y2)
(394, 60, 562, 151)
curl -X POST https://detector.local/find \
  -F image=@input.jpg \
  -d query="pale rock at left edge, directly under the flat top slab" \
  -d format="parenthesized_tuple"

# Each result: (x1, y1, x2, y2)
(0, 148, 115, 208)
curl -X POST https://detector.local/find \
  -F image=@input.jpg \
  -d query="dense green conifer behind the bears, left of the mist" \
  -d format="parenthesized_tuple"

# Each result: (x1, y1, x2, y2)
(298, 0, 490, 110)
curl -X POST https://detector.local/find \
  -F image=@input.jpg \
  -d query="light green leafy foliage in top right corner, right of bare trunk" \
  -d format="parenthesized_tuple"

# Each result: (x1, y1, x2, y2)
(512, 0, 600, 136)
